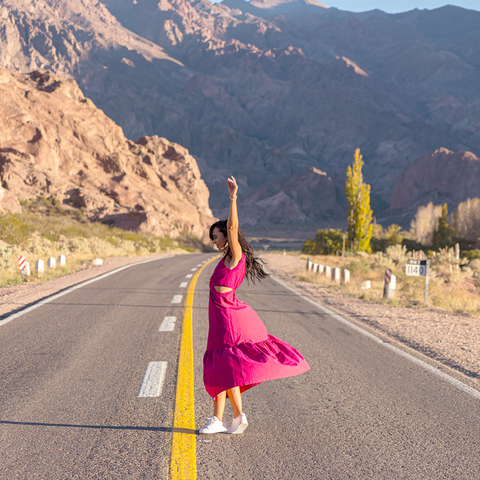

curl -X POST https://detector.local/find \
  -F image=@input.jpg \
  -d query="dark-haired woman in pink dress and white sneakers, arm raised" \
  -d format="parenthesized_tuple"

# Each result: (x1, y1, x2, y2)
(200, 177, 310, 434)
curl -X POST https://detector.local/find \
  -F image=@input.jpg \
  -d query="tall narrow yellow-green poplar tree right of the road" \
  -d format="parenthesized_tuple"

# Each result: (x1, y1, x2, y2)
(345, 148, 373, 252)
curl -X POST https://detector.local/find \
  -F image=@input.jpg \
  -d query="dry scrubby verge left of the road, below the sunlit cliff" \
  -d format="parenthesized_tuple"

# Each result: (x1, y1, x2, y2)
(0, 201, 191, 287)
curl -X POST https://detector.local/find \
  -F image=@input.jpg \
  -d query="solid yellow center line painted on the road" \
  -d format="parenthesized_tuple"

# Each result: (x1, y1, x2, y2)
(170, 255, 220, 480)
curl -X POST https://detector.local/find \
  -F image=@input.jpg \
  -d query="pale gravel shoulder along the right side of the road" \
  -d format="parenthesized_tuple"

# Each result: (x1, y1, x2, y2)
(262, 254, 480, 387)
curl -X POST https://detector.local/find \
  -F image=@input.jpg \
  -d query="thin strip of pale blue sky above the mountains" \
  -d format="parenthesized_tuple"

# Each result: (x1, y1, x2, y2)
(211, 0, 480, 13)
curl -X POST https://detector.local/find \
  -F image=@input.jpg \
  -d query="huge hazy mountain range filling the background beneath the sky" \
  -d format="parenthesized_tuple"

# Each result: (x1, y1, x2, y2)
(0, 0, 480, 231)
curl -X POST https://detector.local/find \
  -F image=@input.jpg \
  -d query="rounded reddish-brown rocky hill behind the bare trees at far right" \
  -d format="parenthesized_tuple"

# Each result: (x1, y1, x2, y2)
(391, 148, 480, 222)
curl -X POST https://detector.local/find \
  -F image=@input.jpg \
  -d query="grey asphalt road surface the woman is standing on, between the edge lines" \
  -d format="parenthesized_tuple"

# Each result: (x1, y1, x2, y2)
(0, 254, 480, 480)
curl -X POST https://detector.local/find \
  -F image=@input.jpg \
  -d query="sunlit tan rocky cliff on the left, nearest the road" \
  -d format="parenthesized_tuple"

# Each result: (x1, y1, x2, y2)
(0, 68, 214, 238)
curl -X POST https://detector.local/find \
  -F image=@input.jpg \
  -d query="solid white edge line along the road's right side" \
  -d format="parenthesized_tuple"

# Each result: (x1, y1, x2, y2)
(270, 275, 480, 400)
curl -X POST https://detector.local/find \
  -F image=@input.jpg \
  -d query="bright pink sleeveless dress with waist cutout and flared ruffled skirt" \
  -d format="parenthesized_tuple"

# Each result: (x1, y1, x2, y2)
(203, 254, 310, 399)
